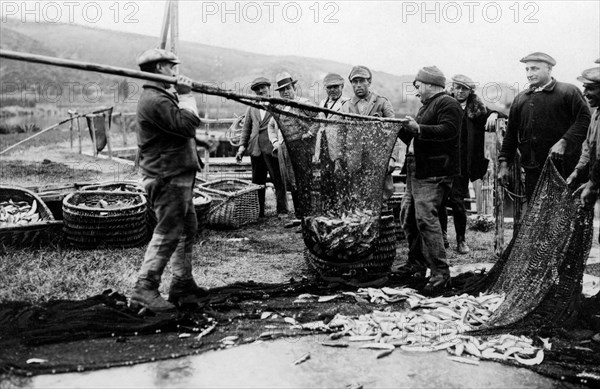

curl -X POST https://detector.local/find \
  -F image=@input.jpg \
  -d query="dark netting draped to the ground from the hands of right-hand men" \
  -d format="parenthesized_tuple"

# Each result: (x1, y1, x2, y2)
(470, 159, 593, 329)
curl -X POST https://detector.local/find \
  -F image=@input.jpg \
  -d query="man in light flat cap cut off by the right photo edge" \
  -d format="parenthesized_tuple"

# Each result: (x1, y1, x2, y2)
(567, 66, 600, 209)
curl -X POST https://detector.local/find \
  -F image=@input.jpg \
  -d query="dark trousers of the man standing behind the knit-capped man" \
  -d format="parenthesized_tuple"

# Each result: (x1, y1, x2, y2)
(440, 176, 469, 242)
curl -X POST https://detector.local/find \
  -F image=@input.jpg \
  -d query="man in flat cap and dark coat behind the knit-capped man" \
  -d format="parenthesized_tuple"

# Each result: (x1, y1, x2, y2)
(440, 74, 506, 254)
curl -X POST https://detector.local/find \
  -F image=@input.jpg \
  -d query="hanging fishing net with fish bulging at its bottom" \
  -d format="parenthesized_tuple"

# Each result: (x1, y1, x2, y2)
(273, 109, 400, 280)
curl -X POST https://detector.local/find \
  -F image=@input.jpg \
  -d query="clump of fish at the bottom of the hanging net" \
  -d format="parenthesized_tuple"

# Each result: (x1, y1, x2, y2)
(304, 210, 378, 261)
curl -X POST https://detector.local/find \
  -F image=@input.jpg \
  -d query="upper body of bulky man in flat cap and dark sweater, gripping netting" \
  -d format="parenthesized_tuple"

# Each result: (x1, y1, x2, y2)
(498, 52, 590, 201)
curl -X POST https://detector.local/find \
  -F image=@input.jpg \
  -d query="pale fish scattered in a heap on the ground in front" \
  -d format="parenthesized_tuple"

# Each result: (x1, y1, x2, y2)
(263, 288, 551, 365)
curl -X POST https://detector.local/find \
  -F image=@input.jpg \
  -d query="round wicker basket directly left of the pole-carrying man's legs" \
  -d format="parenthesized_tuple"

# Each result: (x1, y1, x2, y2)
(63, 191, 148, 248)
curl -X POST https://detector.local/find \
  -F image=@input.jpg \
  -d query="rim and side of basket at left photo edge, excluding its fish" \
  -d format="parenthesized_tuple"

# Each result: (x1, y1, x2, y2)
(0, 186, 62, 247)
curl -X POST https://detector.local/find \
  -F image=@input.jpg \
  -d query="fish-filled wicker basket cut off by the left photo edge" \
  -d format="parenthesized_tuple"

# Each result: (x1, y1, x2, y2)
(0, 186, 62, 246)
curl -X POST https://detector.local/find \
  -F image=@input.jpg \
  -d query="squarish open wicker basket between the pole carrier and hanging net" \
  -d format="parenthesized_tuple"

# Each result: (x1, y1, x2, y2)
(198, 179, 262, 228)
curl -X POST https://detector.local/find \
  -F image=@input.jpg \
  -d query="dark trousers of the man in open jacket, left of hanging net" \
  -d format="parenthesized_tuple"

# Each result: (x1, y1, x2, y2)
(250, 154, 288, 217)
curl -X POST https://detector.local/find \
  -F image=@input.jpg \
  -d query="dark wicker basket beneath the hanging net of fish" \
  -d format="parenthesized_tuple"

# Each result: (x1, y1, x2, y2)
(304, 210, 396, 284)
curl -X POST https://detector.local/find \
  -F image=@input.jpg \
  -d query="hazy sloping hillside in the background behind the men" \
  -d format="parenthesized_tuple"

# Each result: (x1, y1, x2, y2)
(0, 19, 510, 117)
